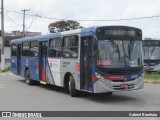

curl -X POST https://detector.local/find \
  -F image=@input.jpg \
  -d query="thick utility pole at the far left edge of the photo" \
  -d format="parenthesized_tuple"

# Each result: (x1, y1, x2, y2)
(1, 0, 5, 71)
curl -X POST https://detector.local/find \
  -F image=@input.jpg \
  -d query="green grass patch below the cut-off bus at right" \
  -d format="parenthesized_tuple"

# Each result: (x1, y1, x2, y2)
(144, 73, 160, 83)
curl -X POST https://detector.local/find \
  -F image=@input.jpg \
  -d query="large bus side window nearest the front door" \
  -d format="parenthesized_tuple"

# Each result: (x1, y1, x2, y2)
(63, 35, 78, 58)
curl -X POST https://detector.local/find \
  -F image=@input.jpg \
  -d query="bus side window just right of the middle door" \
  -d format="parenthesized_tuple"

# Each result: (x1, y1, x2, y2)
(49, 38, 62, 58)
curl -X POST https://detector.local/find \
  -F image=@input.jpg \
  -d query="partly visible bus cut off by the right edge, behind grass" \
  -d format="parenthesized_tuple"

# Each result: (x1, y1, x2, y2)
(143, 40, 160, 73)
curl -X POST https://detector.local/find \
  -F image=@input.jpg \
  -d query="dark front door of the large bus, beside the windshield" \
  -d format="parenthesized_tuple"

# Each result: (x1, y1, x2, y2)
(80, 37, 92, 90)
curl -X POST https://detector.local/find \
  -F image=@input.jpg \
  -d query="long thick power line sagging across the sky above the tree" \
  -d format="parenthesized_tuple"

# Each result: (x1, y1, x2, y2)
(5, 9, 160, 22)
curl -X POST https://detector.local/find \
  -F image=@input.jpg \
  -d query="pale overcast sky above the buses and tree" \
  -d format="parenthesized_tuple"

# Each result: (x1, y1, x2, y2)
(0, 0, 160, 39)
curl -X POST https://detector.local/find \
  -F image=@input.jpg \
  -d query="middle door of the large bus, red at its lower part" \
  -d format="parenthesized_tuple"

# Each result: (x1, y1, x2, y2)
(39, 41, 48, 81)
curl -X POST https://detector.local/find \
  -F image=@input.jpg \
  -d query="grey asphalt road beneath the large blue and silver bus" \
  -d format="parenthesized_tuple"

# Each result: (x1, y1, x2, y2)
(0, 73, 160, 120)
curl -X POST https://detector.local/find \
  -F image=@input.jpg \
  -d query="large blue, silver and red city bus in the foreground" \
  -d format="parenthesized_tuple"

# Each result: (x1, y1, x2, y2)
(11, 26, 144, 96)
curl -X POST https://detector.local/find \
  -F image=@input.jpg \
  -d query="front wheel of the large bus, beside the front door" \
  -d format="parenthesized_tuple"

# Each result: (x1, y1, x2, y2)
(69, 76, 77, 97)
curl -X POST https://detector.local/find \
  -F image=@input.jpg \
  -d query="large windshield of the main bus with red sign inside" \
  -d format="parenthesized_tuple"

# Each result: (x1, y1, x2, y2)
(97, 40, 142, 68)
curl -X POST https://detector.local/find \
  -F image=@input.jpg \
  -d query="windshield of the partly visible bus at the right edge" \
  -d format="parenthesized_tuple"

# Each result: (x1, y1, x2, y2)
(144, 46, 160, 60)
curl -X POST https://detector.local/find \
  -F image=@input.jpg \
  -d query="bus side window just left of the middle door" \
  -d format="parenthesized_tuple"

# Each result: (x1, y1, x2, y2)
(29, 41, 38, 57)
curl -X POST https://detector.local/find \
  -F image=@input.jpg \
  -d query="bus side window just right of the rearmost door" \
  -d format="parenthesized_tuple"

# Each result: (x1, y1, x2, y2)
(22, 42, 30, 57)
